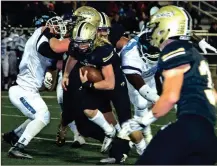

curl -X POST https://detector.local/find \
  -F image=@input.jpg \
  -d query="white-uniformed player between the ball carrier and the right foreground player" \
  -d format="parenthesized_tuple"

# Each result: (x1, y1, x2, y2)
(117, 6, 216, 157)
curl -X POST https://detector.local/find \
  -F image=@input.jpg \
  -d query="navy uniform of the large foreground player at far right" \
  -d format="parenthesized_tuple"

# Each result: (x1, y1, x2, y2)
(136, 41, 217, 165)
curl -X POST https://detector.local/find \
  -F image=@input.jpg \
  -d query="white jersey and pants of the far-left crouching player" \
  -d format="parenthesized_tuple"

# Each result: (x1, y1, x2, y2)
(9, 28, 52, 128)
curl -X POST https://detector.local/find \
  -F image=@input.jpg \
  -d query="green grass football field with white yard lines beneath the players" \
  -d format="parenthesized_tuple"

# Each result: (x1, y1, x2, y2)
(1, 92, 217, 165)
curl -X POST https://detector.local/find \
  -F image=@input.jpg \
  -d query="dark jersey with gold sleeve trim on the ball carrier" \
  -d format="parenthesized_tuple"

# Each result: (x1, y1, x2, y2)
(72, 44, 125, 83)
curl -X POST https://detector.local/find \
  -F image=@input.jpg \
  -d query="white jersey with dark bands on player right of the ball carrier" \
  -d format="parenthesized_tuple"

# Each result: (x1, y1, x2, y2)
(120, 36, 157, 86)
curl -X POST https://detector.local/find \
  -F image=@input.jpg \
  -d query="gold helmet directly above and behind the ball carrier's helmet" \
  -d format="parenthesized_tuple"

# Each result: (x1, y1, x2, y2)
(73, 6, 100, 27)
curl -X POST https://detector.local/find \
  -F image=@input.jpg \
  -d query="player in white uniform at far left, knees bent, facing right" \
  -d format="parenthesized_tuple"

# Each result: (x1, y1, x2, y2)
(3, 16, 66, 159)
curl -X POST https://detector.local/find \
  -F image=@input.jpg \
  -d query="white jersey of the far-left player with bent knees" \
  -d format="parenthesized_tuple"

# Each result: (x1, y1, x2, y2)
(17, 28, 52, 91)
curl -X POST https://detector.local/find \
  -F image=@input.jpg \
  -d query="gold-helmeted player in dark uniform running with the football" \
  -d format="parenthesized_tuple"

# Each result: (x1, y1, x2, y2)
(63, 22, 130, 151)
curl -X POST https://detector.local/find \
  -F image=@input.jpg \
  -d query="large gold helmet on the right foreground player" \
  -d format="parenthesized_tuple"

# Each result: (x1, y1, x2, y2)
(148, 5, 192, 47)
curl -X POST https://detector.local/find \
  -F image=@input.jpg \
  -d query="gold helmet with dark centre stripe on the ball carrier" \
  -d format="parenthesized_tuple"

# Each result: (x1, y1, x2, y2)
(72, 21, 97, 53)
